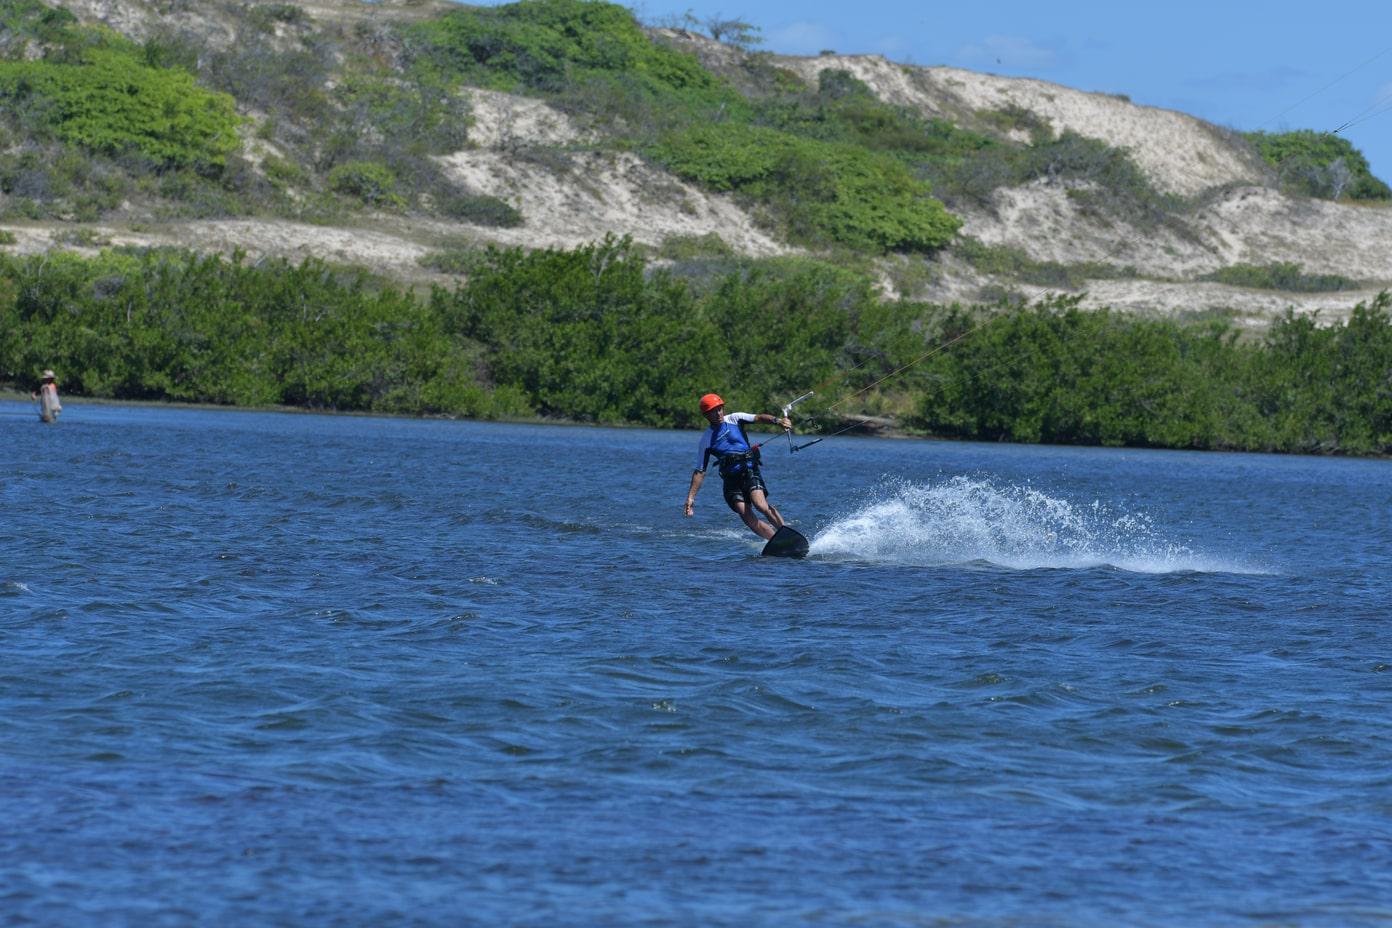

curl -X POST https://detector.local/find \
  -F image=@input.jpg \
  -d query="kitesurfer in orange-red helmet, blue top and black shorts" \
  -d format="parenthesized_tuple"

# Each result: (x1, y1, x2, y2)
(686, 394, 792, 540)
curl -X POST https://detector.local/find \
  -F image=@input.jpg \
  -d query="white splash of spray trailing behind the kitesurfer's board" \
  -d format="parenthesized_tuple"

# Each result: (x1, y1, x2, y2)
(812, 477, 1256, 573)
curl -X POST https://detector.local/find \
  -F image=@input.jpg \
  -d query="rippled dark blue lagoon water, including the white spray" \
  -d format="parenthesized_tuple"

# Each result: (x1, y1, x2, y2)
(0, 402, 1392, 927)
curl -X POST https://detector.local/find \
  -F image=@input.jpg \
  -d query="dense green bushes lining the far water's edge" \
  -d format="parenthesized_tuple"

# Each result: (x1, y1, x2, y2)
(0, 238, 1392, 455)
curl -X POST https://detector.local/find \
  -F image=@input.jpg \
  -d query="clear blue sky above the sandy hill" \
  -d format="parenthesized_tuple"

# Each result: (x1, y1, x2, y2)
(464, 0, 1392, 182)
